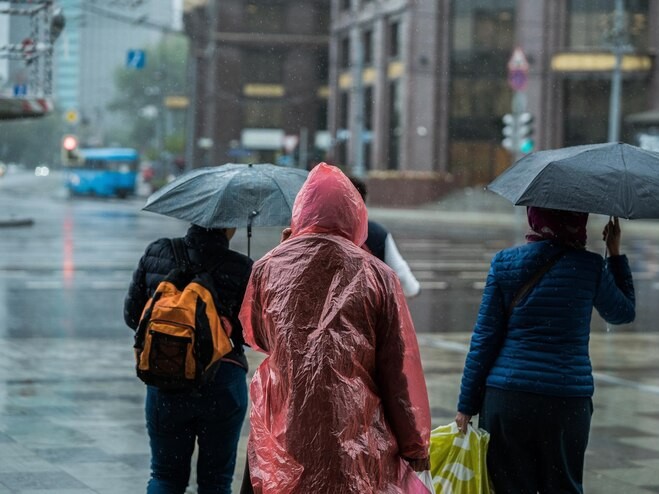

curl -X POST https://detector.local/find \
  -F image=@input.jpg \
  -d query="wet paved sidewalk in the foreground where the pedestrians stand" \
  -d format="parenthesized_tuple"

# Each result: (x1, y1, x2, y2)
(0, 333, 659, 494)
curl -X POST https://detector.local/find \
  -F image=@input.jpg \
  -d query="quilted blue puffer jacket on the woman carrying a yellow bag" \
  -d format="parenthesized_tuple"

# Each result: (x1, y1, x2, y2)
(458, 241, 635, 415)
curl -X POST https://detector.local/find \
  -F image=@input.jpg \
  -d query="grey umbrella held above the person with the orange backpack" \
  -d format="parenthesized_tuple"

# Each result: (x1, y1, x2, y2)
(142, 163, 308, 255)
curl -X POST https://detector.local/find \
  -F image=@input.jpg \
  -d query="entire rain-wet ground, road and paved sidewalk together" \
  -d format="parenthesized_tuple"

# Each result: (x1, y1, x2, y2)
(0, 174, 659, 494)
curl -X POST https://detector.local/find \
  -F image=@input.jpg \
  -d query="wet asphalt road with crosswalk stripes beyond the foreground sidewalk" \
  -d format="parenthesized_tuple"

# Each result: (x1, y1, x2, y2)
(0, 168, 659, 338)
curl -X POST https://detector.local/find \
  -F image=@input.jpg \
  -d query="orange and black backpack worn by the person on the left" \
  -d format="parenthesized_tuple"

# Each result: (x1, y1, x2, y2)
(134, 238, 233, 391)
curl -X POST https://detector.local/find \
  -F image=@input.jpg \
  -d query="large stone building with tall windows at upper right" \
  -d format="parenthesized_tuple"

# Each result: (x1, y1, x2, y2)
(328, 0, 659, 200)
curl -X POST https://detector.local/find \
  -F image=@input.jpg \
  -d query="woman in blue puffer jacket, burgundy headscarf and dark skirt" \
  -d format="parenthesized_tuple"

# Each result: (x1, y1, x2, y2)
(455, 207, 635, 494)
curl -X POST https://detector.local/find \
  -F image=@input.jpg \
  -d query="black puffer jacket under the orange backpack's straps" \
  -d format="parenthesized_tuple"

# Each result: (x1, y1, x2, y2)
(124, 225, 253, 367)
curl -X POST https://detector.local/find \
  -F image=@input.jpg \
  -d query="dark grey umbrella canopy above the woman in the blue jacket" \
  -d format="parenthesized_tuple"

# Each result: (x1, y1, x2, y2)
(487, 142, 659, 219)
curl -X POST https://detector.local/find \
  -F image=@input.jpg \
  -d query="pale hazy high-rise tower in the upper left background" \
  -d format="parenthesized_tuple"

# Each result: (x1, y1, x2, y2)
(53, 0, 174, 145)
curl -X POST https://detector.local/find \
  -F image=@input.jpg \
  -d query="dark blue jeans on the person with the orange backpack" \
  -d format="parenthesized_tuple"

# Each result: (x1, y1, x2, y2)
(146, 362, 247, 494)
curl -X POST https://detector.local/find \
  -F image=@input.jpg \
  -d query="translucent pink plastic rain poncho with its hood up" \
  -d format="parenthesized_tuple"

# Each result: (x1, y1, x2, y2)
(240, 163, 430, 494)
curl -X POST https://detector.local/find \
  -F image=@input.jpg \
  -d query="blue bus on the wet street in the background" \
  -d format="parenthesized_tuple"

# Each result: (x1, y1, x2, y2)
(66, 148, 139, 198)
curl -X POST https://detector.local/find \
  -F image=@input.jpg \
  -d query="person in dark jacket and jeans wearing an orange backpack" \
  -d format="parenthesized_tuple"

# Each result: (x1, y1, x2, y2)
(124, 225, 252, 494)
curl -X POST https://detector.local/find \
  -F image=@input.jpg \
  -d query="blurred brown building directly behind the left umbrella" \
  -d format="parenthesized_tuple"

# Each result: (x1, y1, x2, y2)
(184, 0, 329, 167)
